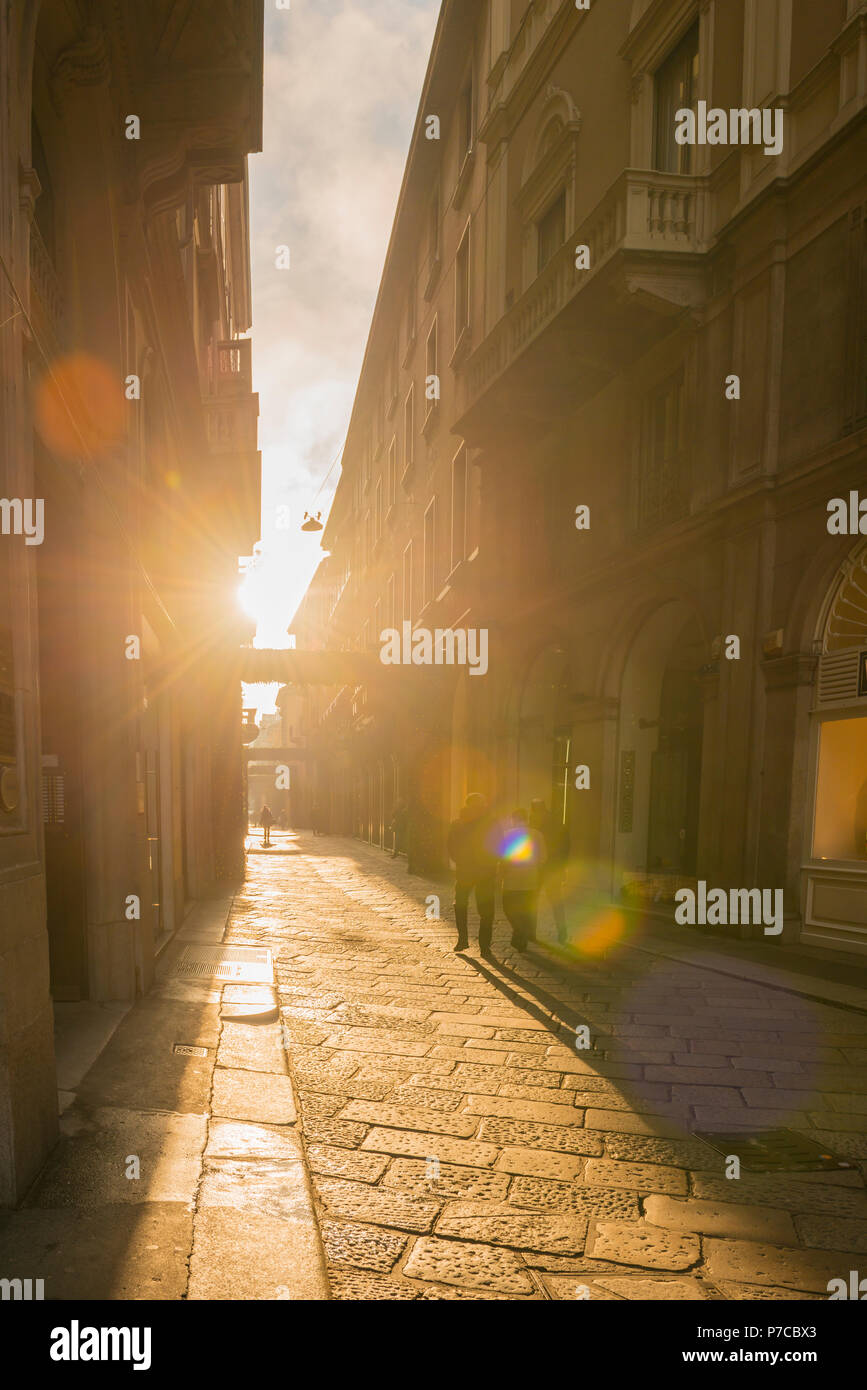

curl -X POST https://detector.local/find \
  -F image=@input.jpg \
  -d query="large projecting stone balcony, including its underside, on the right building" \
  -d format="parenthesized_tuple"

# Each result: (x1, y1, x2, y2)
(454, 170, 709, 442)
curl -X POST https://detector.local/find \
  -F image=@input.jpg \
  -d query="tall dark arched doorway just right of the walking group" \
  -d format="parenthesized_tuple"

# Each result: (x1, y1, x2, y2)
(614, 600, 704, 899)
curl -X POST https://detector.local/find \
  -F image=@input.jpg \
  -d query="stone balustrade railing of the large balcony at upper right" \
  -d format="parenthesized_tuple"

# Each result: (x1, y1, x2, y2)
(461, 170, 707, 409)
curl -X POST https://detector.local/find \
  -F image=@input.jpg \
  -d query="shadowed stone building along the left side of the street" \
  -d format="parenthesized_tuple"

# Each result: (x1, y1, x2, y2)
(0, 0, 263, 1202)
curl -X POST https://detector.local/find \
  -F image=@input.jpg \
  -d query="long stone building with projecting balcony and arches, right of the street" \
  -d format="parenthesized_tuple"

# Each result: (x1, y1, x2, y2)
(299, 0, 867, 951)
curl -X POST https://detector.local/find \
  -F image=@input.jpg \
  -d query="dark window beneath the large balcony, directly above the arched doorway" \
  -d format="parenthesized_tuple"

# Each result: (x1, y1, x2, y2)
(638, 371, 686, 525)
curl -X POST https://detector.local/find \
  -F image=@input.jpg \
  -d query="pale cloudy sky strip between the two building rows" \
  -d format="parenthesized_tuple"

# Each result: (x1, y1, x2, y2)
(242, 0, 439, 709)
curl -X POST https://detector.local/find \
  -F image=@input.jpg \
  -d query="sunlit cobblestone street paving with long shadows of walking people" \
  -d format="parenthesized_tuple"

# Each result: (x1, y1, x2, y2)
(226, 837, 867, 1300)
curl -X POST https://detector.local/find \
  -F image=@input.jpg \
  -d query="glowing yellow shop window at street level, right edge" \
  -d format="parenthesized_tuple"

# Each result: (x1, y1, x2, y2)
(813, 717, 867, 862)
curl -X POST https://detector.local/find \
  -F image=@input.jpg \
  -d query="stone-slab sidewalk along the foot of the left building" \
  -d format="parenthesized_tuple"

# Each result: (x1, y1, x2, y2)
(0, 878, 328, 1300)
